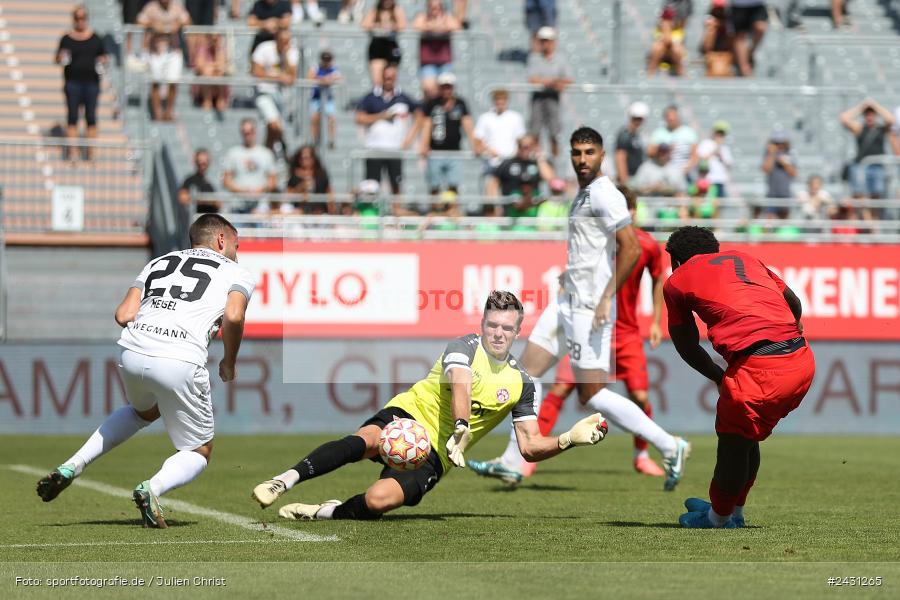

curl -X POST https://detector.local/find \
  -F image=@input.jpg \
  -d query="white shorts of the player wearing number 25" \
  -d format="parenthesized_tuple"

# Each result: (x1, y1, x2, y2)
(119, 350, 213, 450)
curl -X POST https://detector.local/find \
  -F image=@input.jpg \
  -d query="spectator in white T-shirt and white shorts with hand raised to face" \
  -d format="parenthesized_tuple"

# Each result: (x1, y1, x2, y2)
(250, 29, 300, 160)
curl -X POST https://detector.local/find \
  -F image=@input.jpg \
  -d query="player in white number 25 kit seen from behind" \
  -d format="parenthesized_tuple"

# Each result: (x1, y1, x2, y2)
(37, 214, 255, 528)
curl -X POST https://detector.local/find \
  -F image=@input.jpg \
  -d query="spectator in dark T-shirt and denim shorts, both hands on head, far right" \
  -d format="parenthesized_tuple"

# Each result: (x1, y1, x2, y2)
(841, 98, 894, 198)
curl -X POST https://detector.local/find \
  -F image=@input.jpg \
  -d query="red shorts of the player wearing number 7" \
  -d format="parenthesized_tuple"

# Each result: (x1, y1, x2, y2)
(716, 344, 816, 442)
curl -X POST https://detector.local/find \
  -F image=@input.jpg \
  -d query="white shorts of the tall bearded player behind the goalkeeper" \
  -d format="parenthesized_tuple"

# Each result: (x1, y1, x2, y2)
(528, 294, 616, 373)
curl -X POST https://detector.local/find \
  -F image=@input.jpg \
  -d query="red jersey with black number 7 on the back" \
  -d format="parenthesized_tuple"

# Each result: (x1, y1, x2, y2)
(663, 251, 800, 363)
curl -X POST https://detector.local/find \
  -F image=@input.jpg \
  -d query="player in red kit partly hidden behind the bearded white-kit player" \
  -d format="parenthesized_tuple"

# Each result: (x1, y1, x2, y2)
(522, 186, 665, 477)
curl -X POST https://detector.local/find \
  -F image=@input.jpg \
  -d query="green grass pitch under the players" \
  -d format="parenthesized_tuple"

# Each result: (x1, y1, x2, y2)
(0, 434, 900, 598)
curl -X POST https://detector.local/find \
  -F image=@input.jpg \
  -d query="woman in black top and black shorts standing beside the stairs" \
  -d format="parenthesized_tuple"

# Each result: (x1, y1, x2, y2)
(55, 4, 107, 160)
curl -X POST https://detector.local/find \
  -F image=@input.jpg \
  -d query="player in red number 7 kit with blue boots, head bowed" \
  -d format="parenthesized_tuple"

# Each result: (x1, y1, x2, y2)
(663, 227, 816, 528)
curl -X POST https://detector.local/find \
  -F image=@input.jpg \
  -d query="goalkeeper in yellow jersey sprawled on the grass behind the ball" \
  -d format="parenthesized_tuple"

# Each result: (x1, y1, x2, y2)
(252, 291, 606, 520)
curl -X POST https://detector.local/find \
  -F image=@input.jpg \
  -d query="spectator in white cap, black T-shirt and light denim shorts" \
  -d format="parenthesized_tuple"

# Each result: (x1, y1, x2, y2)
(421, 73, 475, 195)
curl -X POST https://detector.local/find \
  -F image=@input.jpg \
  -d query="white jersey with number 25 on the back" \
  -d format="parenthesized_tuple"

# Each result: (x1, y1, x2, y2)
(119, 248, 256, 367)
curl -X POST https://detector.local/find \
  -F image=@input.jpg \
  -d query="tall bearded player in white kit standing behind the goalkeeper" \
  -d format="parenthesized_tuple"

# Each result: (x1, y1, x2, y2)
(469, 127, 690, 490)
